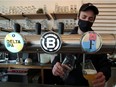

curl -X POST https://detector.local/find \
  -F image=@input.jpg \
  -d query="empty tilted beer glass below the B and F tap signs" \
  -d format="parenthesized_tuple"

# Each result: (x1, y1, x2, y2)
(62, 55, 76, 80)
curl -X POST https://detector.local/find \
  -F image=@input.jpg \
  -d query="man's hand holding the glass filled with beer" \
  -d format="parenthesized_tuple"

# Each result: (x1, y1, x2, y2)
(92, 72, 105, 87)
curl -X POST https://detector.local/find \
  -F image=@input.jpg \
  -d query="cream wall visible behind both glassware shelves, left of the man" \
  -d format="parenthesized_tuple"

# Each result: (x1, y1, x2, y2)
(0, 0, 82, 34)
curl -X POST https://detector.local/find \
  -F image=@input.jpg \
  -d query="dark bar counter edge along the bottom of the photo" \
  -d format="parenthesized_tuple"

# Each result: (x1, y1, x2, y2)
(0, 82, 87, 87)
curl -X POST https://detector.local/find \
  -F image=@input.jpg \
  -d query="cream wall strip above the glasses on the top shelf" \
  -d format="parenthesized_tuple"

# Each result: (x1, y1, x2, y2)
(0, 0, 82, 12)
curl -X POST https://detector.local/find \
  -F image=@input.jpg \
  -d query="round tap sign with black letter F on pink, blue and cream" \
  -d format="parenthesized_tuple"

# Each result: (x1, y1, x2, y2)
(81, 31, 102, 53)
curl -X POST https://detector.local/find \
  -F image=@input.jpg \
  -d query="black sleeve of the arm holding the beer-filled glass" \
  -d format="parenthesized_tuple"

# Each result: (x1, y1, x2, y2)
(92, 54, 111, 81)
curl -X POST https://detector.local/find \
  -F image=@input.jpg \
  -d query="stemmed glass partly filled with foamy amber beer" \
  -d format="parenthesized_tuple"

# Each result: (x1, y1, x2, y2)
(83, 60, 97, 87)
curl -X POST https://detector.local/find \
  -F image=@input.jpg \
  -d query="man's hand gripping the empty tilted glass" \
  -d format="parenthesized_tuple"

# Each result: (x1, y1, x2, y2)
(52, 62, 64, 77)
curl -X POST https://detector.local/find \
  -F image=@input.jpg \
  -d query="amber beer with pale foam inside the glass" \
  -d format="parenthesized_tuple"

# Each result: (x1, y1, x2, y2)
(84, 69, 97, 87)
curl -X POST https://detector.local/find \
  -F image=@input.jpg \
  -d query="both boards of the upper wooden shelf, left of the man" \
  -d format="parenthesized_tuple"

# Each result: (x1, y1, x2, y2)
(0, 13, 77, 21)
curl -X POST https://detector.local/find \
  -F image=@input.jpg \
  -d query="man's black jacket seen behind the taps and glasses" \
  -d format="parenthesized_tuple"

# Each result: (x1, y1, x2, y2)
(52, 27, 111, 86)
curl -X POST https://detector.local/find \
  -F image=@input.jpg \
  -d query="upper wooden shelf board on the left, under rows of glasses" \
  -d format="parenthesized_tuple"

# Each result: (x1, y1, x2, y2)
(0, 13, 51, 20)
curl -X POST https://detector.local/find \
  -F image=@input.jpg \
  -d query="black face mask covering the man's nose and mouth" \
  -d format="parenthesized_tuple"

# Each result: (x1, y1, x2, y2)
(78, 19, 93, 32)
